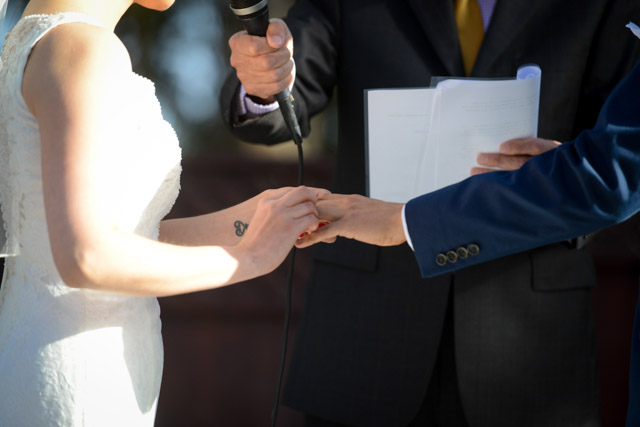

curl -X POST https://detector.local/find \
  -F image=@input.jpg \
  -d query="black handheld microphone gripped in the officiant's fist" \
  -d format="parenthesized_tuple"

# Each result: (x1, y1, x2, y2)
(229, 0, 302, 145)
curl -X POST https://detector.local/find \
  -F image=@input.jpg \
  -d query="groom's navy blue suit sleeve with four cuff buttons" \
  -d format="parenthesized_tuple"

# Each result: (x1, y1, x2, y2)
(405, 63, 640, 277)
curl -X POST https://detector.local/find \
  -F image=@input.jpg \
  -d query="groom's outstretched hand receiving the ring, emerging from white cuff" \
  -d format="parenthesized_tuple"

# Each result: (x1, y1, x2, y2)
(296, 194, 406, 248)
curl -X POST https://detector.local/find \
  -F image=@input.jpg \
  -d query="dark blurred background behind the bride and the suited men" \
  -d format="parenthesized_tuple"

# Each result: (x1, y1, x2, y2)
(0, 0, 640, 427)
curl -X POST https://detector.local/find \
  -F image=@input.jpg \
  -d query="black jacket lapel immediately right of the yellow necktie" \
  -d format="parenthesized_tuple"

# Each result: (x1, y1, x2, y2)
(471, 0, 541, 77)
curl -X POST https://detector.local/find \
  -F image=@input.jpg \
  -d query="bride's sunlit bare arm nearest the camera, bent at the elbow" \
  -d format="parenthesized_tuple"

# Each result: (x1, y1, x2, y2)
(23, 24, 317, 296)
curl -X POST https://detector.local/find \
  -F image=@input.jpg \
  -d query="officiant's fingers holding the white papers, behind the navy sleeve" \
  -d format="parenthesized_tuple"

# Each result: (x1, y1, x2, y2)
(471, 138, 560, 175)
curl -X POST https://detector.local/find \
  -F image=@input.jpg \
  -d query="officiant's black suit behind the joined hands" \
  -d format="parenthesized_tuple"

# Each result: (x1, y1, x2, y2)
(221, 0, 640, 427)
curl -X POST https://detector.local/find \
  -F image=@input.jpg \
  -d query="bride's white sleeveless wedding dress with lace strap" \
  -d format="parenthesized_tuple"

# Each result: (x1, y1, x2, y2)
(0, 13, 181, 427)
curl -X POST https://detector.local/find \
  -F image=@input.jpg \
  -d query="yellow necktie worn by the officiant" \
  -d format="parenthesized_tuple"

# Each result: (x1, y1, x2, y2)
(455, 0, 484, 76)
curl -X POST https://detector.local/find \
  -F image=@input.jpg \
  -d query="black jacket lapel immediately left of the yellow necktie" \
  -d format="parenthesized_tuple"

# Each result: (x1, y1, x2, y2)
(407, 0, 462, 76)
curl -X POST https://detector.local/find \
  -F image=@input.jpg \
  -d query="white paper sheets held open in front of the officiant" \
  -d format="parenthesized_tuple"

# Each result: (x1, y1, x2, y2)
(366, 66, 541, 202)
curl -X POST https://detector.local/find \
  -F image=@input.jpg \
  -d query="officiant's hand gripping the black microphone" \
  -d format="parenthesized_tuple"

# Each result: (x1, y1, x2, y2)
(229, 19, 296, 104)
